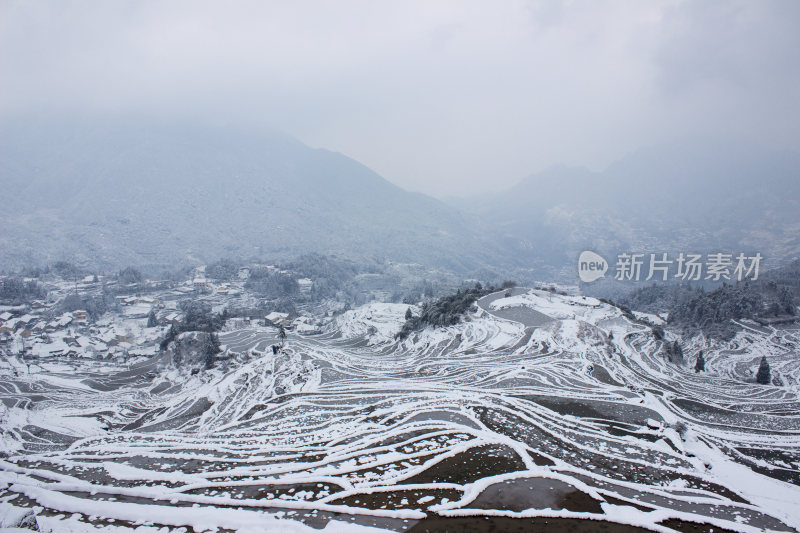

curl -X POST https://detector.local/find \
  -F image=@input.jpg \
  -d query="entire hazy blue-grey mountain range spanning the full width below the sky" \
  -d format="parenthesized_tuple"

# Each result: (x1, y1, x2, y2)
(0, 116, 800, 276)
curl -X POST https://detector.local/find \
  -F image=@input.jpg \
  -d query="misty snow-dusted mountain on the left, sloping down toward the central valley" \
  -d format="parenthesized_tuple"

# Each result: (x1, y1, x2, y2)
(0, 117, 504, 270)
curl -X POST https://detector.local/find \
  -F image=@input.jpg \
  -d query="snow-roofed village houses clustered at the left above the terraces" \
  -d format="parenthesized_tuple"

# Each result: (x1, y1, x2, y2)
(0, 267, 324, 372)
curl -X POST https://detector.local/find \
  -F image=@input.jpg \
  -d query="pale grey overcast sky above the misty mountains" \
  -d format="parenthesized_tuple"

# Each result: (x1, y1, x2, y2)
(0, 0, 800, 196)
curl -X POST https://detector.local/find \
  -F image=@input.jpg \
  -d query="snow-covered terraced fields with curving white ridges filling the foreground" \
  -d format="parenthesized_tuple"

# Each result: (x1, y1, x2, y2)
(0, 290, 800, 531)
